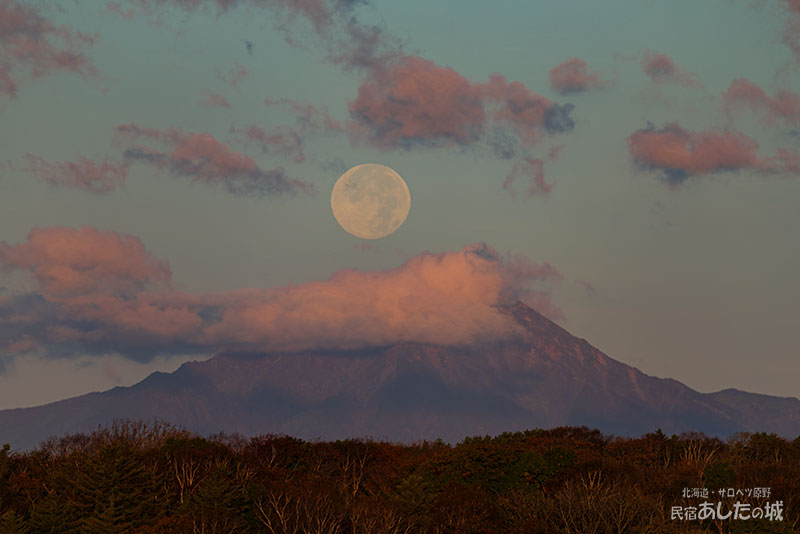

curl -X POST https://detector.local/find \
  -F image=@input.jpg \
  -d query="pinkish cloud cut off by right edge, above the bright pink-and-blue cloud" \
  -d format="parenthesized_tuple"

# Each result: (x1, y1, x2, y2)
(722, 78, 800, 125)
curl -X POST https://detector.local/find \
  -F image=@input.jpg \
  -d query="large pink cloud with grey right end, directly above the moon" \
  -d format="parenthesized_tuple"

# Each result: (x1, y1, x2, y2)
(349, 56, 574, 149)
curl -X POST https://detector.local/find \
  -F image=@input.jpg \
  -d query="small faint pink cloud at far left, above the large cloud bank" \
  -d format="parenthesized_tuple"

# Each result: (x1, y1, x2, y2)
(25, 154, 128, 194)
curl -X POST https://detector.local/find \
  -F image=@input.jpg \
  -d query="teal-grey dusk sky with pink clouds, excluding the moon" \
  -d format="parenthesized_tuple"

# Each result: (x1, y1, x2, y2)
(0, 0, 800, 409)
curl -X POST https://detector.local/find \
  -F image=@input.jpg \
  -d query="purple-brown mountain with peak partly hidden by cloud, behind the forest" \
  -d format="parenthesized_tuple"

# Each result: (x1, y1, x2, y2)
(0, 302, 800, 450)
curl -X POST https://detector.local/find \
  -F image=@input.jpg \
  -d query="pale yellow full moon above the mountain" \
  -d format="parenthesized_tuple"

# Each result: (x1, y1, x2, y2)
(331, 163, 411, 239)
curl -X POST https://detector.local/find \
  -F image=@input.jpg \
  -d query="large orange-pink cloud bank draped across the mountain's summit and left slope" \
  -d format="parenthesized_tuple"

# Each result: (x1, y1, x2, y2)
(0, 227, 561, 361)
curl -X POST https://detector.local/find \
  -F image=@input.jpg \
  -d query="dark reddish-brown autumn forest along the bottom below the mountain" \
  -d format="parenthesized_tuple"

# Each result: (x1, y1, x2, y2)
(0, 421, 800, 534)
